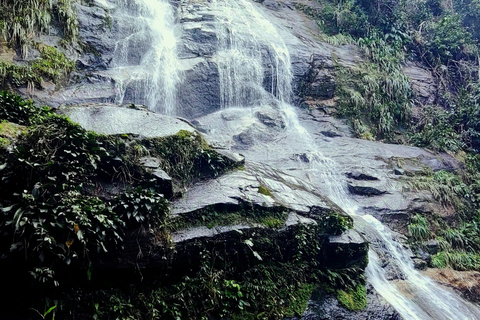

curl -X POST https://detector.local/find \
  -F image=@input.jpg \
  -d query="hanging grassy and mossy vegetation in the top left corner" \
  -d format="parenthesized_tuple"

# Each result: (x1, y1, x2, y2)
(0, 0, 78, 90)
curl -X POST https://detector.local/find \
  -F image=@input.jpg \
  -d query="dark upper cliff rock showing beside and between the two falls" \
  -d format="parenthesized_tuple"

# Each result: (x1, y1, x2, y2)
(15, 0, 362, 119)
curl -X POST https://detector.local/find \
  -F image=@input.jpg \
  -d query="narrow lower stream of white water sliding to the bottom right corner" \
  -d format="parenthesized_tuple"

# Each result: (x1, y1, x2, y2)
(300, 139, 480, 320)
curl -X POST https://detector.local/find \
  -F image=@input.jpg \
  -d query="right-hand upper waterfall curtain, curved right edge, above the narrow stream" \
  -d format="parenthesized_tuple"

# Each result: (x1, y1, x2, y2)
(212, 0, 292, 108)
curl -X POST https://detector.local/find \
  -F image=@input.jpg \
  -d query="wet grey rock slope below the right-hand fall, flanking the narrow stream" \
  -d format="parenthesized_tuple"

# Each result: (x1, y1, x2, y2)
(195, 106, 458, 227)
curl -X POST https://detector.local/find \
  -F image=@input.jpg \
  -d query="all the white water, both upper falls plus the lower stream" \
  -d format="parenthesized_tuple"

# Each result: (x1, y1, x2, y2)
(114, 0, 480, 320)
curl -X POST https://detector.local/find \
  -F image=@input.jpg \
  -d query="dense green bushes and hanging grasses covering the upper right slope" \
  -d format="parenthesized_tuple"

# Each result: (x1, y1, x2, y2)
(299, 0, 480, 152)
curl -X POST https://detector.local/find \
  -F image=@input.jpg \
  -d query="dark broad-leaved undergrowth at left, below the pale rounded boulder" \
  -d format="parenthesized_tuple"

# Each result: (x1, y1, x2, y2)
(0, 92, 234, 290)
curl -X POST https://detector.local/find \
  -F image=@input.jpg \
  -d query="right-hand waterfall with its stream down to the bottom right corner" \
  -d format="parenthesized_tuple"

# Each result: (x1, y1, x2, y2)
(207, 0, 480, 320)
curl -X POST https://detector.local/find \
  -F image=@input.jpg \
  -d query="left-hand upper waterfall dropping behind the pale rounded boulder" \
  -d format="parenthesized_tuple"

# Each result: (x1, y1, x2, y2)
(109, 0, 180, 115)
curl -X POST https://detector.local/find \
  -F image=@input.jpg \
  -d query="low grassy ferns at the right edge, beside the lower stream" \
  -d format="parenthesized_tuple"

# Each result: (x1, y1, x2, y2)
(408, 155, 480, 270)
